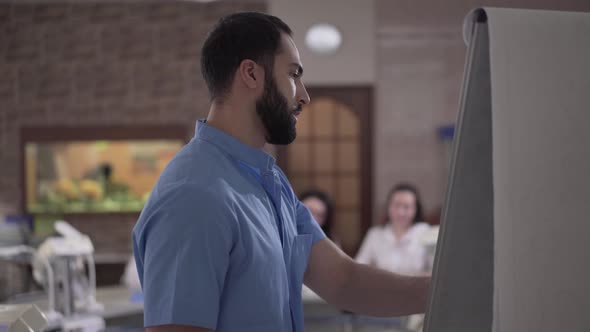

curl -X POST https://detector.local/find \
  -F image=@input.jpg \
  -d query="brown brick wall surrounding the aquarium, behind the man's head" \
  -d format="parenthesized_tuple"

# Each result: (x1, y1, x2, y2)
(0, 1, 266, 253)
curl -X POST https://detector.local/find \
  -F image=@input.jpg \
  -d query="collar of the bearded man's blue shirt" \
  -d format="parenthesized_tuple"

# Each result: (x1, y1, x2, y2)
(195, 120, 276, 170)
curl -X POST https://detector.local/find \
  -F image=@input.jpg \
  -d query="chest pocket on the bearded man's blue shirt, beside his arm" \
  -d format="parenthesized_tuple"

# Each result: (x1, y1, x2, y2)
(289, 234, 313, 331)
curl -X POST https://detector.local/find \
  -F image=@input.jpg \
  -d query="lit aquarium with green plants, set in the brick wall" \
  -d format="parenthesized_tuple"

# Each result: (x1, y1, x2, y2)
(24, 126, 185, 214)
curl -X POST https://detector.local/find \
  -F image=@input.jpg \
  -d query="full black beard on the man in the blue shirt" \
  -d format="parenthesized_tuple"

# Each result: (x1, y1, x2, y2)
(256, 76, 301, 145)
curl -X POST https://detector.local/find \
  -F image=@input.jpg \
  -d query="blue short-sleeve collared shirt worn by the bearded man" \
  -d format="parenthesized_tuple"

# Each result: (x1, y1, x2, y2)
(133, 121, 325, 332)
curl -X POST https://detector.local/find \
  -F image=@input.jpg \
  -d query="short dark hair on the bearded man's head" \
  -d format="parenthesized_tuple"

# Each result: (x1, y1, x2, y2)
(201, 12, 292, 100)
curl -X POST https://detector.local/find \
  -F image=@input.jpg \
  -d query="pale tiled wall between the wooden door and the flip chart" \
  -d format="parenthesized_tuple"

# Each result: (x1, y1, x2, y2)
(373, 0, 590, 219)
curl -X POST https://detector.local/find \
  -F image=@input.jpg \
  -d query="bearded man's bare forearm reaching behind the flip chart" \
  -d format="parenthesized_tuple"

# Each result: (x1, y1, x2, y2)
(336, 263, 430, 316)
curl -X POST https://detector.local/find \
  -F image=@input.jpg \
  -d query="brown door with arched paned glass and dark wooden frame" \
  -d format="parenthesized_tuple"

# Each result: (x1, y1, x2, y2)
(279, 87, 372, 255)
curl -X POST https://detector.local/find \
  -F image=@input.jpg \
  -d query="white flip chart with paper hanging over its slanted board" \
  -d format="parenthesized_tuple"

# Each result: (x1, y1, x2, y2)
(424, 8, 590, 332)
